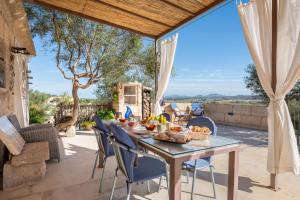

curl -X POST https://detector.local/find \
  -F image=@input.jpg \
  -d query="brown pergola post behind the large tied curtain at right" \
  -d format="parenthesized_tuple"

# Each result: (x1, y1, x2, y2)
(270, 0, 279, 191)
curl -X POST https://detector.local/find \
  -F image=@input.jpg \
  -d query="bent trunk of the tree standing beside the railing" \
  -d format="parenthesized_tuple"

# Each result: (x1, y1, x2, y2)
(56, 80, 79, 131)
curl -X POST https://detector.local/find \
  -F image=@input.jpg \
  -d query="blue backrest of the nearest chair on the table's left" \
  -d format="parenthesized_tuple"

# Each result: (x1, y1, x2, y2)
(110, 124, 137, 181)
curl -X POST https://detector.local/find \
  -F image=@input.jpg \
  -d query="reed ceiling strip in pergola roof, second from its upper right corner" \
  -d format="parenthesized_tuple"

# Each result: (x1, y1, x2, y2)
(98, 0, 192, 26)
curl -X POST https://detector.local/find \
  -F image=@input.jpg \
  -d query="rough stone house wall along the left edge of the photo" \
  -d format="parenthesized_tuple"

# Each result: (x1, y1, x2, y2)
(0, 0, 35, 188)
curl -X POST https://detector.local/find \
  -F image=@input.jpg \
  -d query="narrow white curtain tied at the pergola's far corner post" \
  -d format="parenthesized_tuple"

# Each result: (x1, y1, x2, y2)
(154, 34, 178, 115)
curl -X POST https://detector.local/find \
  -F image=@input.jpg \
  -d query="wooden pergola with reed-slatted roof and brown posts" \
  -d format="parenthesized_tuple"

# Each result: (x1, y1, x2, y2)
(25, 0, 278, 195)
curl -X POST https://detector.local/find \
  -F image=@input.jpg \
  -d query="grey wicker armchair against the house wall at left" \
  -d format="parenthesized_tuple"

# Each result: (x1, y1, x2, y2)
(8, 115, 60, 162)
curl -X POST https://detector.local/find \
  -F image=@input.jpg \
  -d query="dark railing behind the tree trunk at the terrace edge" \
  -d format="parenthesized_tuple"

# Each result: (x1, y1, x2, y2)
(54, 103, 112, 122)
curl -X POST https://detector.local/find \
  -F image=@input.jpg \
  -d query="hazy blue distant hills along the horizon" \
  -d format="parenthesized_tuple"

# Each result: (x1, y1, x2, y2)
(165, 93, 260, 100)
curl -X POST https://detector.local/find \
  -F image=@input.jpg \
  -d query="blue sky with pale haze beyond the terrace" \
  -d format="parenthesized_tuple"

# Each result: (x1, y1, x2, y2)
(30, 1, 252, 98)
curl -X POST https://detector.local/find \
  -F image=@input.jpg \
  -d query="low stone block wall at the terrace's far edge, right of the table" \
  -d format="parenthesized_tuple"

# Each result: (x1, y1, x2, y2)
(164, 103, 268, 130)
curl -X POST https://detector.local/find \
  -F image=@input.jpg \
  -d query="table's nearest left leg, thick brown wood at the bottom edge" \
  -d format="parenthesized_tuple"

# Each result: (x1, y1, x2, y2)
(169, 160, 182, 200)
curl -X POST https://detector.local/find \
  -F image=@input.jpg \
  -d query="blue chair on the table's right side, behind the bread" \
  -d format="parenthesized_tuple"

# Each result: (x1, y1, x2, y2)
(182, 117, 217, 199)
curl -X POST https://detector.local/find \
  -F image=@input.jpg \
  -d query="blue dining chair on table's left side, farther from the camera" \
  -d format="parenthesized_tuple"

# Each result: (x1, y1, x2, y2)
(92, 115, 115, 192)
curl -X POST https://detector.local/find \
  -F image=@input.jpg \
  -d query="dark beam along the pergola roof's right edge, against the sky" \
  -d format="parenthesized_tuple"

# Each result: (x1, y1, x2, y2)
(156, 0, 225, 39)
